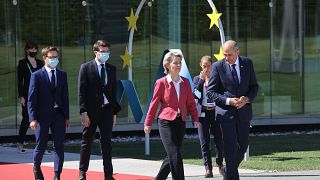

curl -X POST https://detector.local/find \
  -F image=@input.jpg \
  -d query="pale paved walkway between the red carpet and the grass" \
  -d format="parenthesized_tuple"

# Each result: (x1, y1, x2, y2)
(0, 145, 320, 180)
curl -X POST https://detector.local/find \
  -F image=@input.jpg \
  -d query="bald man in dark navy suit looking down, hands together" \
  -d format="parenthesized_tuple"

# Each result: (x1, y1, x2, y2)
(207, 40, 259, 180)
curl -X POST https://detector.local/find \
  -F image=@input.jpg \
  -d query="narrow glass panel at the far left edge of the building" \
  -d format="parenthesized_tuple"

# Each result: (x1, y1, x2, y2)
(0, 1, 16, 128)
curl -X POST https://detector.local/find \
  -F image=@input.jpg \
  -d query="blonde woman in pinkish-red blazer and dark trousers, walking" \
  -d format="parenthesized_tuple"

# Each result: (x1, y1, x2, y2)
(144, 52, 199, 180)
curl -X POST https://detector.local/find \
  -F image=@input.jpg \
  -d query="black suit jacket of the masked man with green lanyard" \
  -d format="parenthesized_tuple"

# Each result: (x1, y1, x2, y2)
(78, 60, 121, 115)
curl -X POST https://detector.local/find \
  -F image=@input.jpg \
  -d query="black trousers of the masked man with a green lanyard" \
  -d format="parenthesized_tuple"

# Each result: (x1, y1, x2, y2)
(79, 107, 113, 178)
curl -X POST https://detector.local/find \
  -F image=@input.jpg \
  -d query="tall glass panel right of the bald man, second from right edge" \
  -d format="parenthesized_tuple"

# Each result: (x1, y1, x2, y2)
(271, 0, 303, 116)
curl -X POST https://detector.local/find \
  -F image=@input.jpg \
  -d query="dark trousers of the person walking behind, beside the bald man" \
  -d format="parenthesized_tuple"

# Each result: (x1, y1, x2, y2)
(198, 110, 223, 170)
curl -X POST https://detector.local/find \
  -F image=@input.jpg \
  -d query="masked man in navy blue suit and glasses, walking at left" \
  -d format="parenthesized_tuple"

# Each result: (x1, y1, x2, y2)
(28, 47, 70, 180)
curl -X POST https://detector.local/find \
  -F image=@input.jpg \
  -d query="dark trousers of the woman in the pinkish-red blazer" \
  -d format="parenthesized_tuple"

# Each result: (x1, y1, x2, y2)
(155, 117, 186, 180)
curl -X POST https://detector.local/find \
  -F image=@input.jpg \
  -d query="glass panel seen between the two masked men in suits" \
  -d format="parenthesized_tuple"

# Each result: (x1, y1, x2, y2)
(58, 0, 87, 125)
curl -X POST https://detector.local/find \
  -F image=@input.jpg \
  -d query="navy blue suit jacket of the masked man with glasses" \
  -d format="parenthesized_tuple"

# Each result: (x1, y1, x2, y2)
(28, 67, 69, 122)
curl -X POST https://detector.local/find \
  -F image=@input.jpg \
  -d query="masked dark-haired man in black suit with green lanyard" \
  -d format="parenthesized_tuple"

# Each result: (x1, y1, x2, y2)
(78, 40, 121, 180)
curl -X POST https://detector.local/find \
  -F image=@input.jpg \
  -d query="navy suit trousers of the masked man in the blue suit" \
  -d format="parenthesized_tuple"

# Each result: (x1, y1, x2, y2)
(33, 108, 66, 173)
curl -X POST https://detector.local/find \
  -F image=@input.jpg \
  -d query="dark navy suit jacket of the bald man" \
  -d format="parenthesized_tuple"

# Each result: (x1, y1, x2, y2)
(207, 56, 259, 121)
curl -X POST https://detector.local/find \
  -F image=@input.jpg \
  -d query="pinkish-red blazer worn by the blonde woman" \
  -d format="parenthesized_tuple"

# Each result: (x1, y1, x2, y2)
(144, 76, 199, 126)
